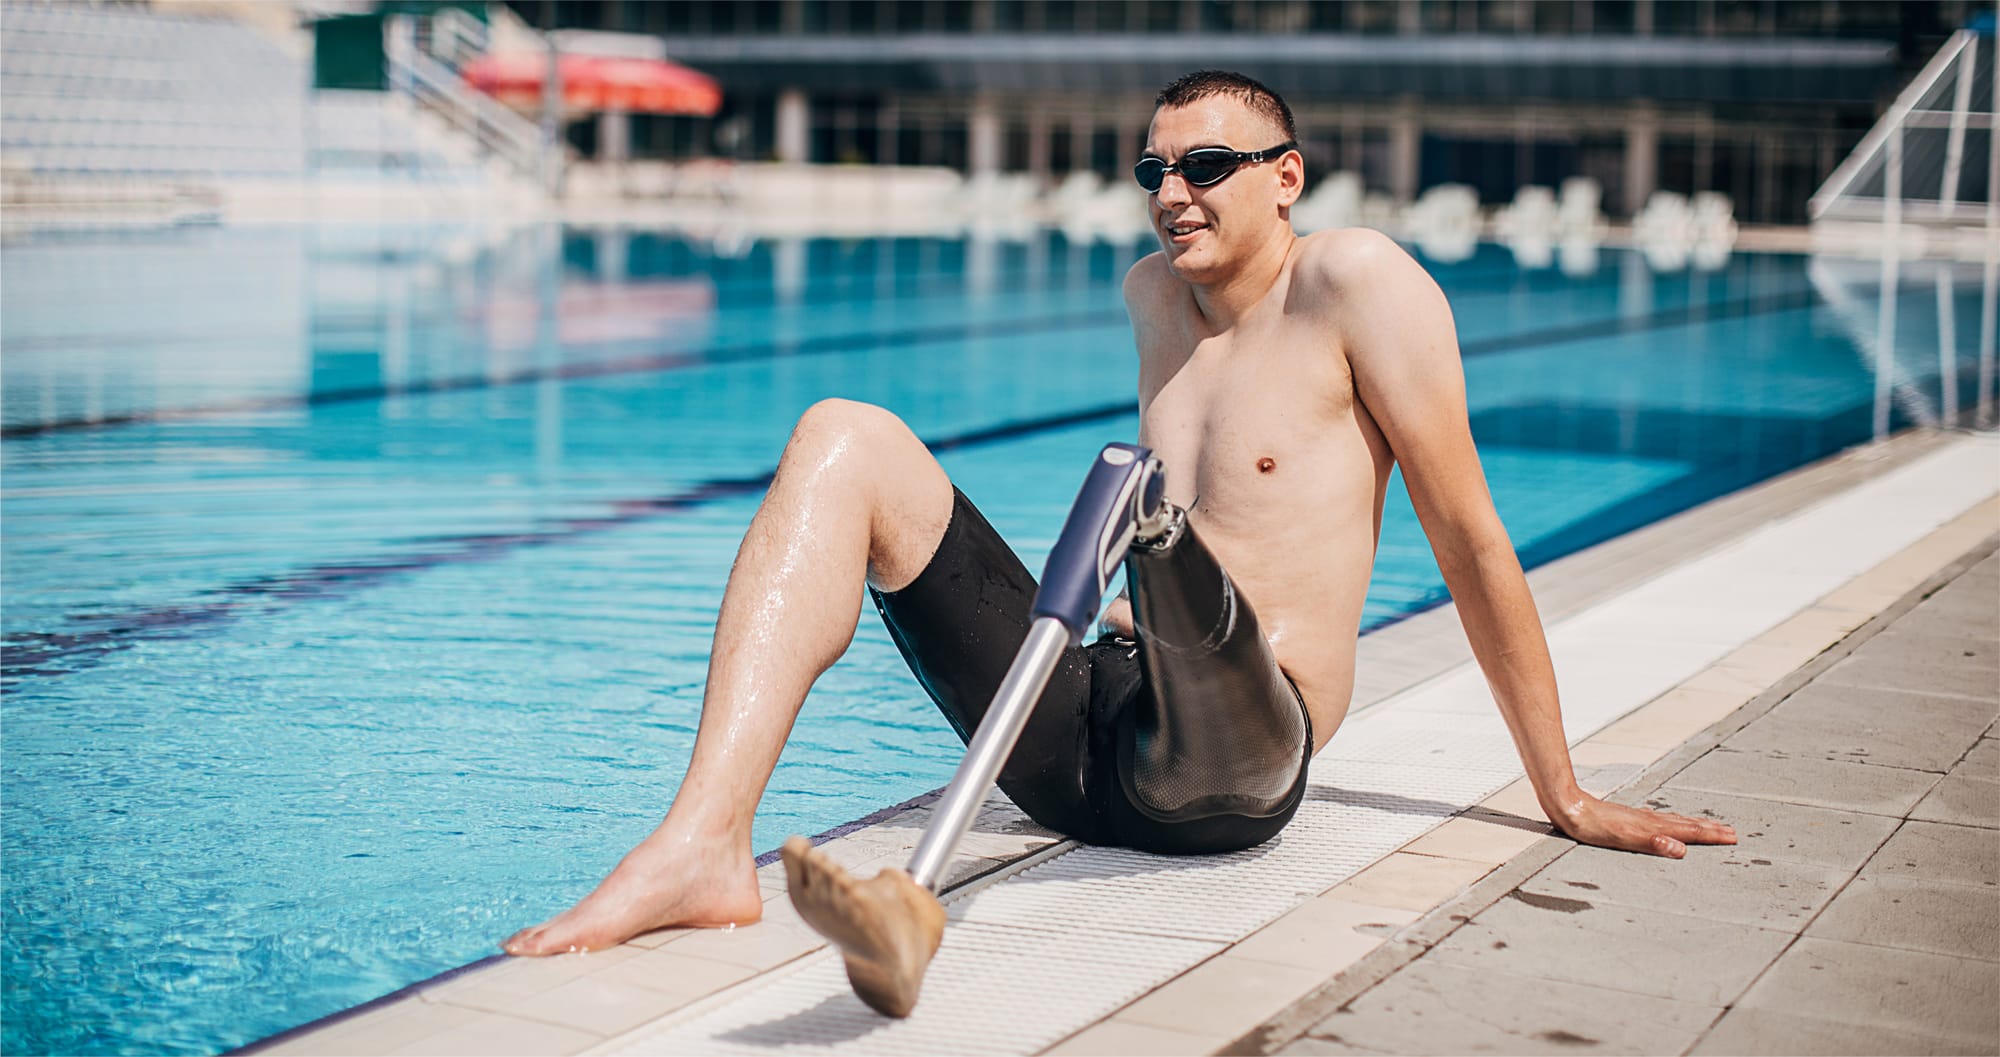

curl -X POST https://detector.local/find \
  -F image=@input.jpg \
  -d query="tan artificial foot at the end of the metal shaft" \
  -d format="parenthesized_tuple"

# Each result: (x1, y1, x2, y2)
(784, 837, 944, 1017)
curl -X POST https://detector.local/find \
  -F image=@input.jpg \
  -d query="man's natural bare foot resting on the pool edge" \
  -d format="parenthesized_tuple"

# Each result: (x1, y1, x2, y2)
(500, 839, 764, 957)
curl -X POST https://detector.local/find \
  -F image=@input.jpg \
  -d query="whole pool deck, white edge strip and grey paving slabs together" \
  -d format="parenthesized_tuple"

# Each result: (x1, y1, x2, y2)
(252, 432, 2000, 1053)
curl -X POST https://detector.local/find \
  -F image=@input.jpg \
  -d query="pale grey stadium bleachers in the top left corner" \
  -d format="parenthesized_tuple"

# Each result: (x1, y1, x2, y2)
(0, 0, 500, 195)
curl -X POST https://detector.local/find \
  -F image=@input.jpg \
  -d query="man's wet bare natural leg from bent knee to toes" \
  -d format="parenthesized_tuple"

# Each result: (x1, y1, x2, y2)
(502, 400, 952, 955)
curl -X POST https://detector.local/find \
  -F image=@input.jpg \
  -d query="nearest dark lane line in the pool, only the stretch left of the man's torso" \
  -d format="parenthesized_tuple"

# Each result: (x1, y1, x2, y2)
(0, 402, 1138, 680)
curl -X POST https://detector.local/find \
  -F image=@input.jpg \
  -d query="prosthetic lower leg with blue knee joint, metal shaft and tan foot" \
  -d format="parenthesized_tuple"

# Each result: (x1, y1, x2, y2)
(784, 444, 1180, 1017)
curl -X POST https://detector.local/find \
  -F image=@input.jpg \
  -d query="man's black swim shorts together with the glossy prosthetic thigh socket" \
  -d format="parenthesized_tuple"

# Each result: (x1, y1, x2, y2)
(870, 492, 1312, 855)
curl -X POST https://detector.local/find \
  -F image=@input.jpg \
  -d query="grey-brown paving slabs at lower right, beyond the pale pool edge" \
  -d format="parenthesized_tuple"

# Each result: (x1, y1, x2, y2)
(1230, 537, 2000, 1055)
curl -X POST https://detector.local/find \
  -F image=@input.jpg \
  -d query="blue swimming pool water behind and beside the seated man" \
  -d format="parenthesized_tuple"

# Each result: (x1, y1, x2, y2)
(0, 226, 1980, 1053)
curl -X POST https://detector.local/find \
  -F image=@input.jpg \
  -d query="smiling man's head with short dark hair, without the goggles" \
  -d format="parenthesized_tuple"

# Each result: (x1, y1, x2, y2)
(1146, 96, 1298, 282)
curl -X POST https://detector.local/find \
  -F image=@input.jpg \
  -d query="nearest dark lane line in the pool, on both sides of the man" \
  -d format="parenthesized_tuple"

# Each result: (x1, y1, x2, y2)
(0, 276, 1812, 680)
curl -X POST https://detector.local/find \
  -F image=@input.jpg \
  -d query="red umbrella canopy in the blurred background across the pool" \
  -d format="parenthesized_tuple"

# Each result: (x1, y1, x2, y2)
(462, 52, 722, 118)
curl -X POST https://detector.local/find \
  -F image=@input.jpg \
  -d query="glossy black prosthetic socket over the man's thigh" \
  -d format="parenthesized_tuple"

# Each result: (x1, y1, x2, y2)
(1118, 526, 1312, 825)
